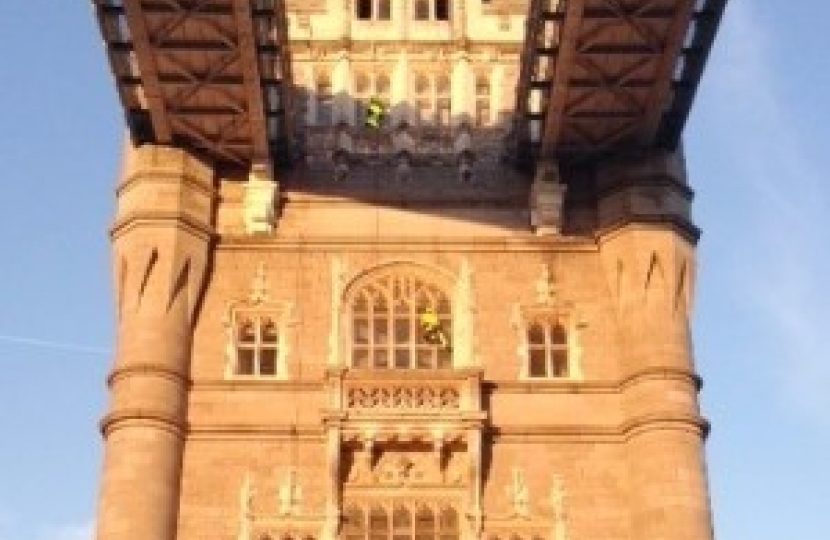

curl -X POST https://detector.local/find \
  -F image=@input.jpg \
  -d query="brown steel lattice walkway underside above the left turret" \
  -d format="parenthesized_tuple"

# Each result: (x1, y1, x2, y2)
(92, 0, 292, 167)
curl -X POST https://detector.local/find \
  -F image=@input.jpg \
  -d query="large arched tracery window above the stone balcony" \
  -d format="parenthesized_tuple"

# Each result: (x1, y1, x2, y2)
(350, 273, 452, 369)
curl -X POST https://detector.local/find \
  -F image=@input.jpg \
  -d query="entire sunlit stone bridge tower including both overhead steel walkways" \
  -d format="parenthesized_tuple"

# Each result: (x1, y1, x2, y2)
(93, 0, 725, 540)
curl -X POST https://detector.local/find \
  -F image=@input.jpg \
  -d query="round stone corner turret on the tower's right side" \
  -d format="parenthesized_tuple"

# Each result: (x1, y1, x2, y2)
(599, 150, 712, 540)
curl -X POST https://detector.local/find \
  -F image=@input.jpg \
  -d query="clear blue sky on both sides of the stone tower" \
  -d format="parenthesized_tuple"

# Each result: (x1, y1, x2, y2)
(0, 0, 830, 540)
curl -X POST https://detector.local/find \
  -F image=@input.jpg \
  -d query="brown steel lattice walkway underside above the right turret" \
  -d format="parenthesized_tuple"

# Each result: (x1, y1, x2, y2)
(513, 0, 726, 161)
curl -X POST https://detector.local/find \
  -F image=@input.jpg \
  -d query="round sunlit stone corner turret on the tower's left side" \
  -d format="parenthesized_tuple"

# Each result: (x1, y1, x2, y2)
(96, 141, 216, 540)
